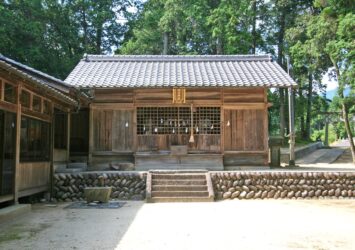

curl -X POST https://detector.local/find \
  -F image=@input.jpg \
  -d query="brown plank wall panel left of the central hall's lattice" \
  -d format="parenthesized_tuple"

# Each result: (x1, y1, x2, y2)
(93, 109, 134, 152)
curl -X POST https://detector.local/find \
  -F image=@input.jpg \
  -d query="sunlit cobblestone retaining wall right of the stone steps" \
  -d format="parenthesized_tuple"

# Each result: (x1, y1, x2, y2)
(211, 171, 355, 199)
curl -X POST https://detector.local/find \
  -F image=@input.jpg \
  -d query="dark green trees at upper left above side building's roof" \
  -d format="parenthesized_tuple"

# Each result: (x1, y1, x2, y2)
(0, 0, 139, 79)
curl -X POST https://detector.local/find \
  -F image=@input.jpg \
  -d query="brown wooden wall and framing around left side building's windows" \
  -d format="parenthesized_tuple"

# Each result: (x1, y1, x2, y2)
(0, 68, 74, 202)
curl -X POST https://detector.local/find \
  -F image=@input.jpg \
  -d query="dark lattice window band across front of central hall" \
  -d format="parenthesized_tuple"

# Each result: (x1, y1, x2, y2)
(137, 107, 221, 135)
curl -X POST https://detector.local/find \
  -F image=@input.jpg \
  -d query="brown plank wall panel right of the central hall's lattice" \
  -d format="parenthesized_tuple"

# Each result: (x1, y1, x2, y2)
(224, 109, 266, 151)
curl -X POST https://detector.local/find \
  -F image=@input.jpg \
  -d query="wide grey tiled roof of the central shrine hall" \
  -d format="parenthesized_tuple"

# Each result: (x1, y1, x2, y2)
(65, 55, 297, 88)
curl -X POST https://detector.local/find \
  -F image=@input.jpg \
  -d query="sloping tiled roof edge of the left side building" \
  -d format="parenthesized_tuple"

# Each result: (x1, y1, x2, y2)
(0, 54, 77, 105)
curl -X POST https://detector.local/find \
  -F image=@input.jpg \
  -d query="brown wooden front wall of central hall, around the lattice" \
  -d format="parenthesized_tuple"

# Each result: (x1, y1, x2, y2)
(91, 87, 268, 168)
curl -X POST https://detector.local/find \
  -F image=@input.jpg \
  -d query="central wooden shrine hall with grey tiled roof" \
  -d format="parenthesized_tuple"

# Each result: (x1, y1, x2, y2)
(65, 55, 296, 170)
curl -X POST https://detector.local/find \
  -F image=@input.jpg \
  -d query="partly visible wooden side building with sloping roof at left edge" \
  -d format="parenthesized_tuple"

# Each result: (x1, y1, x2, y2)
(0, 54, 85, 203)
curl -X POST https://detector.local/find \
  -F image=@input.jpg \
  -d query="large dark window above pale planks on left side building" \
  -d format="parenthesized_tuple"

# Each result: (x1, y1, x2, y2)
(20, 117, 50, 161)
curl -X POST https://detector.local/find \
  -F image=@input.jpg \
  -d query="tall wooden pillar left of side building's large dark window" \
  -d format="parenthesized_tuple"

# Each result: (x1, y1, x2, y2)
(14, 85, 22, 204)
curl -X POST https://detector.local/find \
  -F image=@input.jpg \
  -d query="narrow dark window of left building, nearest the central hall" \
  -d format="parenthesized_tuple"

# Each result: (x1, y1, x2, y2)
(54, 113, 68, 149)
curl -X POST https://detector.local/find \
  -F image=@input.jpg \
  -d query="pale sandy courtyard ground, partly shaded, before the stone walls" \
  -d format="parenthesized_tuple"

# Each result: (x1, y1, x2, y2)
(0, 200, 355, 250)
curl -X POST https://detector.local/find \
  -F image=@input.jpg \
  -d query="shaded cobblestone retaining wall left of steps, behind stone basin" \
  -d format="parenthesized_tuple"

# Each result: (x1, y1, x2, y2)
(53, 172, 147, 201)
